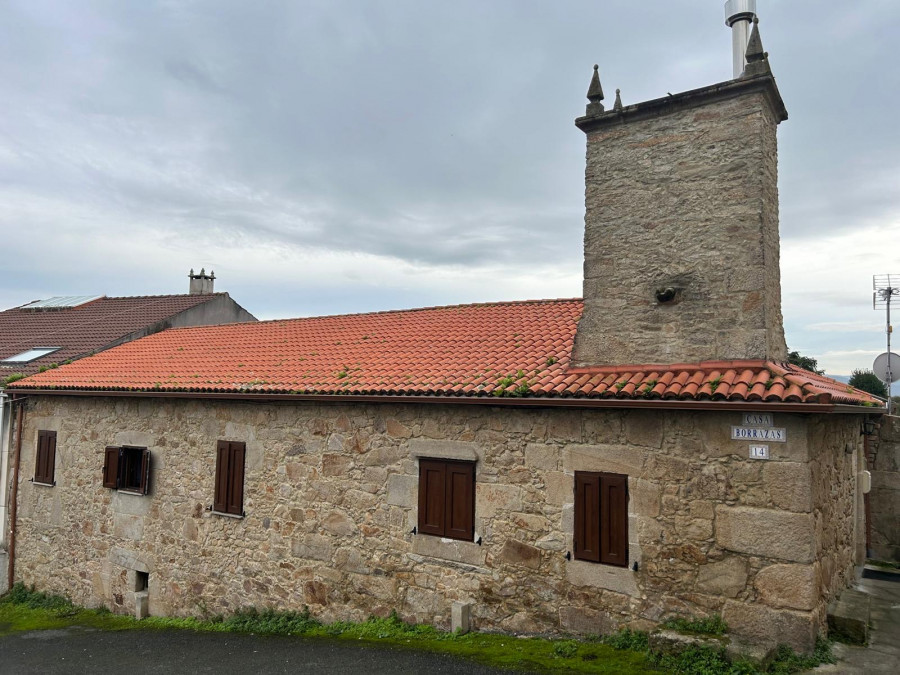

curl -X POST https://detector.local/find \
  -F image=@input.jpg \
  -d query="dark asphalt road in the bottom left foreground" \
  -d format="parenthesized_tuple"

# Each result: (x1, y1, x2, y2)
(0, 627, 508, 675)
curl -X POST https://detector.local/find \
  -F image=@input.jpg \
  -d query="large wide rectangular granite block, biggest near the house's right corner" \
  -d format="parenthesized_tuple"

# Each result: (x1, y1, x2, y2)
(716, 504, 815, 563)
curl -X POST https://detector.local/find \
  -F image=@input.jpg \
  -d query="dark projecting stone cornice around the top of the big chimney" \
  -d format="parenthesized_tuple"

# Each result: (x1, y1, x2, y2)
(575, 73, 788, 133)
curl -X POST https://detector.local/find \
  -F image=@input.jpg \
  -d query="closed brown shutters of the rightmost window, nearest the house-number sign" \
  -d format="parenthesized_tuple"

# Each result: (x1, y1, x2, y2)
(574, 471, 628, 567)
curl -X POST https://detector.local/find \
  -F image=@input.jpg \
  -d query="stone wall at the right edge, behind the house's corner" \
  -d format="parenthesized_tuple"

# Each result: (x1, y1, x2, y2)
(869, 416, 900, 562)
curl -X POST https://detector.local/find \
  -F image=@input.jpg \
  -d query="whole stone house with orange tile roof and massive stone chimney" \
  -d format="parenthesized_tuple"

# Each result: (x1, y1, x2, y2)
(1, 18, 883, 649)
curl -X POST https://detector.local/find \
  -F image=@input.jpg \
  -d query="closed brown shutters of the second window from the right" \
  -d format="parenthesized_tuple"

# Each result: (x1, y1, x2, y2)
(418, 459, 475, 541)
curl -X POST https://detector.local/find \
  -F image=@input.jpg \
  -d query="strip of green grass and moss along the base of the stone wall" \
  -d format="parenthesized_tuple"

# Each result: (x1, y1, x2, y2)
(0, 584, 834, 675)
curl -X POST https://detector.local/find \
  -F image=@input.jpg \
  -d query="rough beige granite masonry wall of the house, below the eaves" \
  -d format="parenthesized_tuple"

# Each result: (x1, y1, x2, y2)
(10, 396, 861, 648)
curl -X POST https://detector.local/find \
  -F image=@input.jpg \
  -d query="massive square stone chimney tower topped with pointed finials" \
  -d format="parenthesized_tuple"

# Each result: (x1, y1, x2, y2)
(572, 23, 787, 367)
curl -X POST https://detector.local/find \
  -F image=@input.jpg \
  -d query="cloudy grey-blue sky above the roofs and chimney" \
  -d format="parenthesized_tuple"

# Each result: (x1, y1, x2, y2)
(0, 0, 900, 374)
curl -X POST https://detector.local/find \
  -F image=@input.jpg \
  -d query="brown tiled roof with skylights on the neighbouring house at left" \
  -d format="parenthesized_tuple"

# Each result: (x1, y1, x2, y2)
(0, 293, 243, 380)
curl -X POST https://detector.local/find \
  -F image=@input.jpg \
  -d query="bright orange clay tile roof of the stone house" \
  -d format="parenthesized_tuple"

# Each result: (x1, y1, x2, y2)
(5, 299, 880, 405)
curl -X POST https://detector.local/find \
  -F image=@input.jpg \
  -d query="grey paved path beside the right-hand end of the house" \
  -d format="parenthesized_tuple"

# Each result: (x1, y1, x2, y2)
(811, 579, 900, 675)
